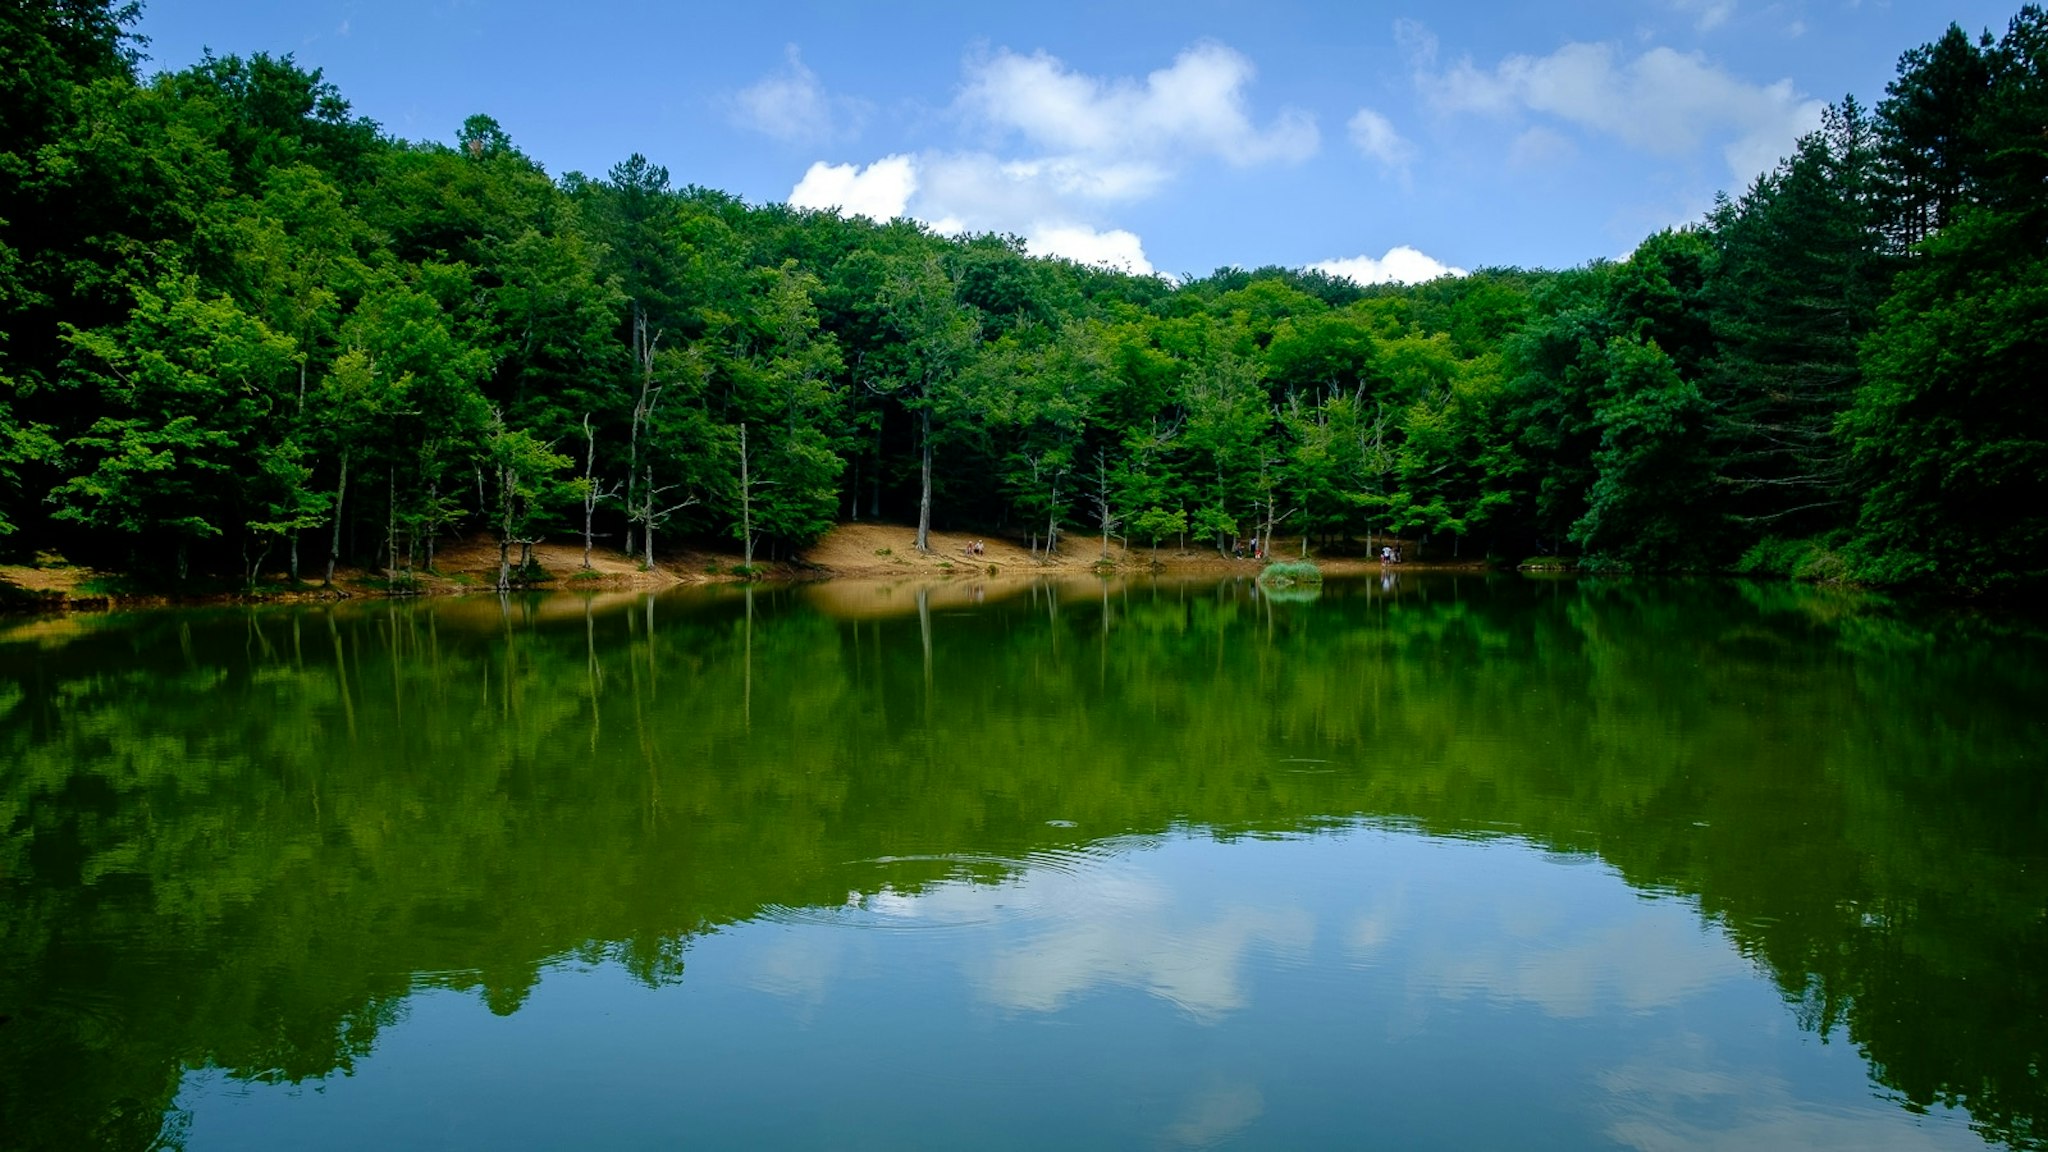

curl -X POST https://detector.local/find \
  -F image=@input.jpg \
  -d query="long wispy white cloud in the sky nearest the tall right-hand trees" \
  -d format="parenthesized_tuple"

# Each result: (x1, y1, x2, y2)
(1397, 29, 1825, 184)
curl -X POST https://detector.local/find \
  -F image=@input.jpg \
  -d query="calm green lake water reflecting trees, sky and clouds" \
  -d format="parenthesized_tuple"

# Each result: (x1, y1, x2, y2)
(0, 576, 2048, 1150)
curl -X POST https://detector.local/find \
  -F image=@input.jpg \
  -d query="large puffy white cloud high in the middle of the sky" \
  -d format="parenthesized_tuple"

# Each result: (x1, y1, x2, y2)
(958, 43, 1319, 166)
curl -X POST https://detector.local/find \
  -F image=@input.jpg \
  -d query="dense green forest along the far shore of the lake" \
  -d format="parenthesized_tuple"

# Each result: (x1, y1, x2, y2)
(0, 0, 2048, 592)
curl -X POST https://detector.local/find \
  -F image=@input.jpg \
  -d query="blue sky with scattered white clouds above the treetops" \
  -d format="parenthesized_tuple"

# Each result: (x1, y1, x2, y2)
(139, 0, 2019, 281)
